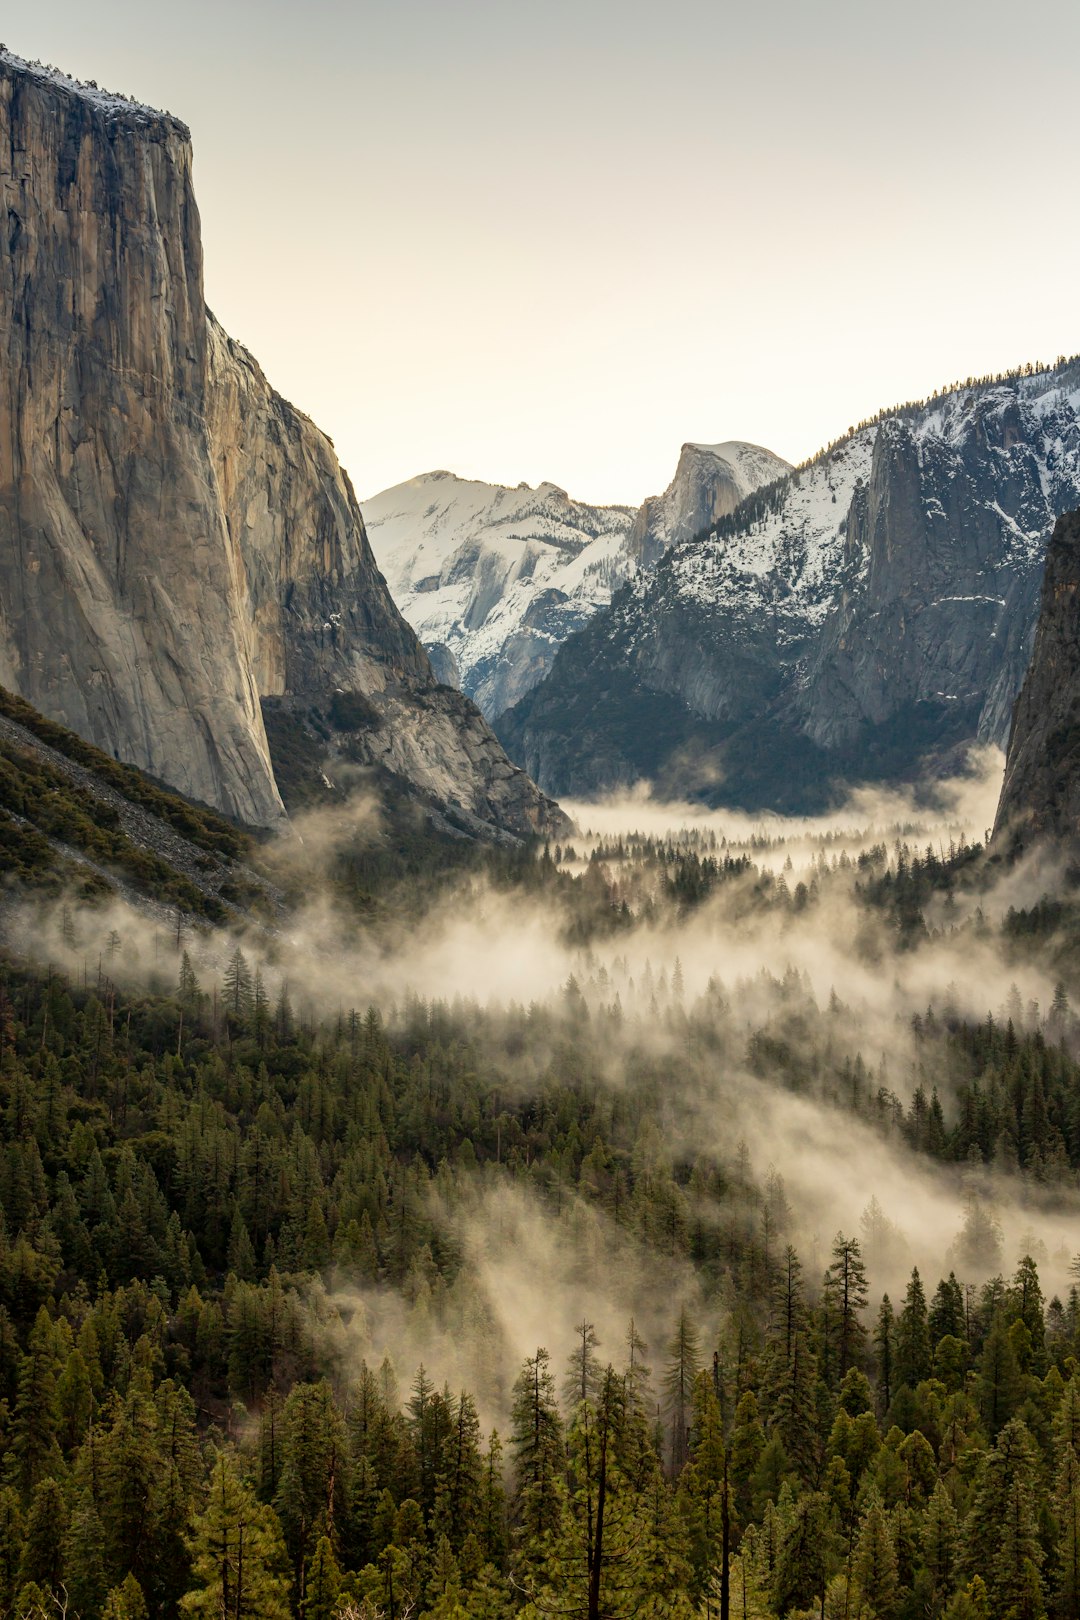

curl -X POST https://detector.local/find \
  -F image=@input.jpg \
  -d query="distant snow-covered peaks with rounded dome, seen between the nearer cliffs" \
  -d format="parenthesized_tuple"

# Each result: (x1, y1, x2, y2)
(363, 441, 789, 716)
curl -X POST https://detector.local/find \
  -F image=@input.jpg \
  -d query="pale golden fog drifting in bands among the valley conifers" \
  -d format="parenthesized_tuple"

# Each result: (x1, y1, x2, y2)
(10, 750, 1080, 1401)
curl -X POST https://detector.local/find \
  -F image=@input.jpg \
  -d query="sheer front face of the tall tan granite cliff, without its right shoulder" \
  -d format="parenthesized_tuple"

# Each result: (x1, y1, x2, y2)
(0, 57, 282, 823)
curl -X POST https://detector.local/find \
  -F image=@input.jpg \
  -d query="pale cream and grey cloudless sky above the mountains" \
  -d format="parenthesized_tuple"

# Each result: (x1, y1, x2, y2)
(14, 0, 1080, 504)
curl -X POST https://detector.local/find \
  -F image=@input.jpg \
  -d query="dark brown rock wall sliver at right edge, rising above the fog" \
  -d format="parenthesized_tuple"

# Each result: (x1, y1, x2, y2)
(994, 512, 1080, 851)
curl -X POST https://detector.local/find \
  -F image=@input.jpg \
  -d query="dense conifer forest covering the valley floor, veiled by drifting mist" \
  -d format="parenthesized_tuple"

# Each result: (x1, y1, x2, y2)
(0, 816, 1080, 1620)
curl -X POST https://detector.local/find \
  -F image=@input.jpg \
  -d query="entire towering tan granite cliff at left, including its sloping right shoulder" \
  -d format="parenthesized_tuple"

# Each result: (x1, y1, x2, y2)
(0, 52, 562, 836)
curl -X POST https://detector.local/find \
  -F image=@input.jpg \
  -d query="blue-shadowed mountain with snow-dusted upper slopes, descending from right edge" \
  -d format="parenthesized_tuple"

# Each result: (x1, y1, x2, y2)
(499, 360, 1080, 810)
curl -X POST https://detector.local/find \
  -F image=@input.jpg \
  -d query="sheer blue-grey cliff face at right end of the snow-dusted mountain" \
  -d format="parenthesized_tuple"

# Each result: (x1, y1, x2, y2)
(795, 388, 1080, 747)
